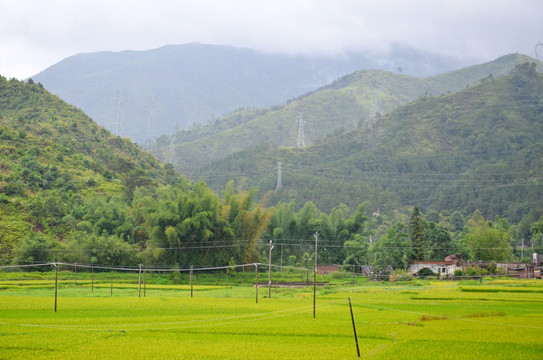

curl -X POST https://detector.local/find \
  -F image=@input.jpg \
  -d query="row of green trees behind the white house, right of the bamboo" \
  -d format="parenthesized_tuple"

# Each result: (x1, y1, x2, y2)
(262, 201, 543, 271)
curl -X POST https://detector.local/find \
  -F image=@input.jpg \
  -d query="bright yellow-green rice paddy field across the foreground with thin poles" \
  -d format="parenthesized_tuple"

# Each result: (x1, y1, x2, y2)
(0, 273, 543, 360)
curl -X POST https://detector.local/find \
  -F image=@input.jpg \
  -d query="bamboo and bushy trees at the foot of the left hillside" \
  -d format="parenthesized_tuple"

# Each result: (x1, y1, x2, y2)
(13, 182, 271, 265)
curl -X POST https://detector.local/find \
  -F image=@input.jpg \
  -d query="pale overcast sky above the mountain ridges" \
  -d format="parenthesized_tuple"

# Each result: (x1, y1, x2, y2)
(0, 0, 543, 79)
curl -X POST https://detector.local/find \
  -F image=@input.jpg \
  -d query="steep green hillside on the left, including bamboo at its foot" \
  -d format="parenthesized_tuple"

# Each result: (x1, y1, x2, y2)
(0, 77, 269, 265)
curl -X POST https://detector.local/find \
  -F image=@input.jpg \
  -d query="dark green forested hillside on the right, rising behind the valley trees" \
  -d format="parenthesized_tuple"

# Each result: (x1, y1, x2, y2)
(194, 63, 543, 222)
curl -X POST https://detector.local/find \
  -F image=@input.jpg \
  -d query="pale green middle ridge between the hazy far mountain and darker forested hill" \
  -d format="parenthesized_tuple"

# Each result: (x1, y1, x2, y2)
(160, 54, 534, 174)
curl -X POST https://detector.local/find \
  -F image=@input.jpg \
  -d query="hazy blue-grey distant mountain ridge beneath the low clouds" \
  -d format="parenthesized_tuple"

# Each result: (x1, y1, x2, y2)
(32, 43, 463, 144)
